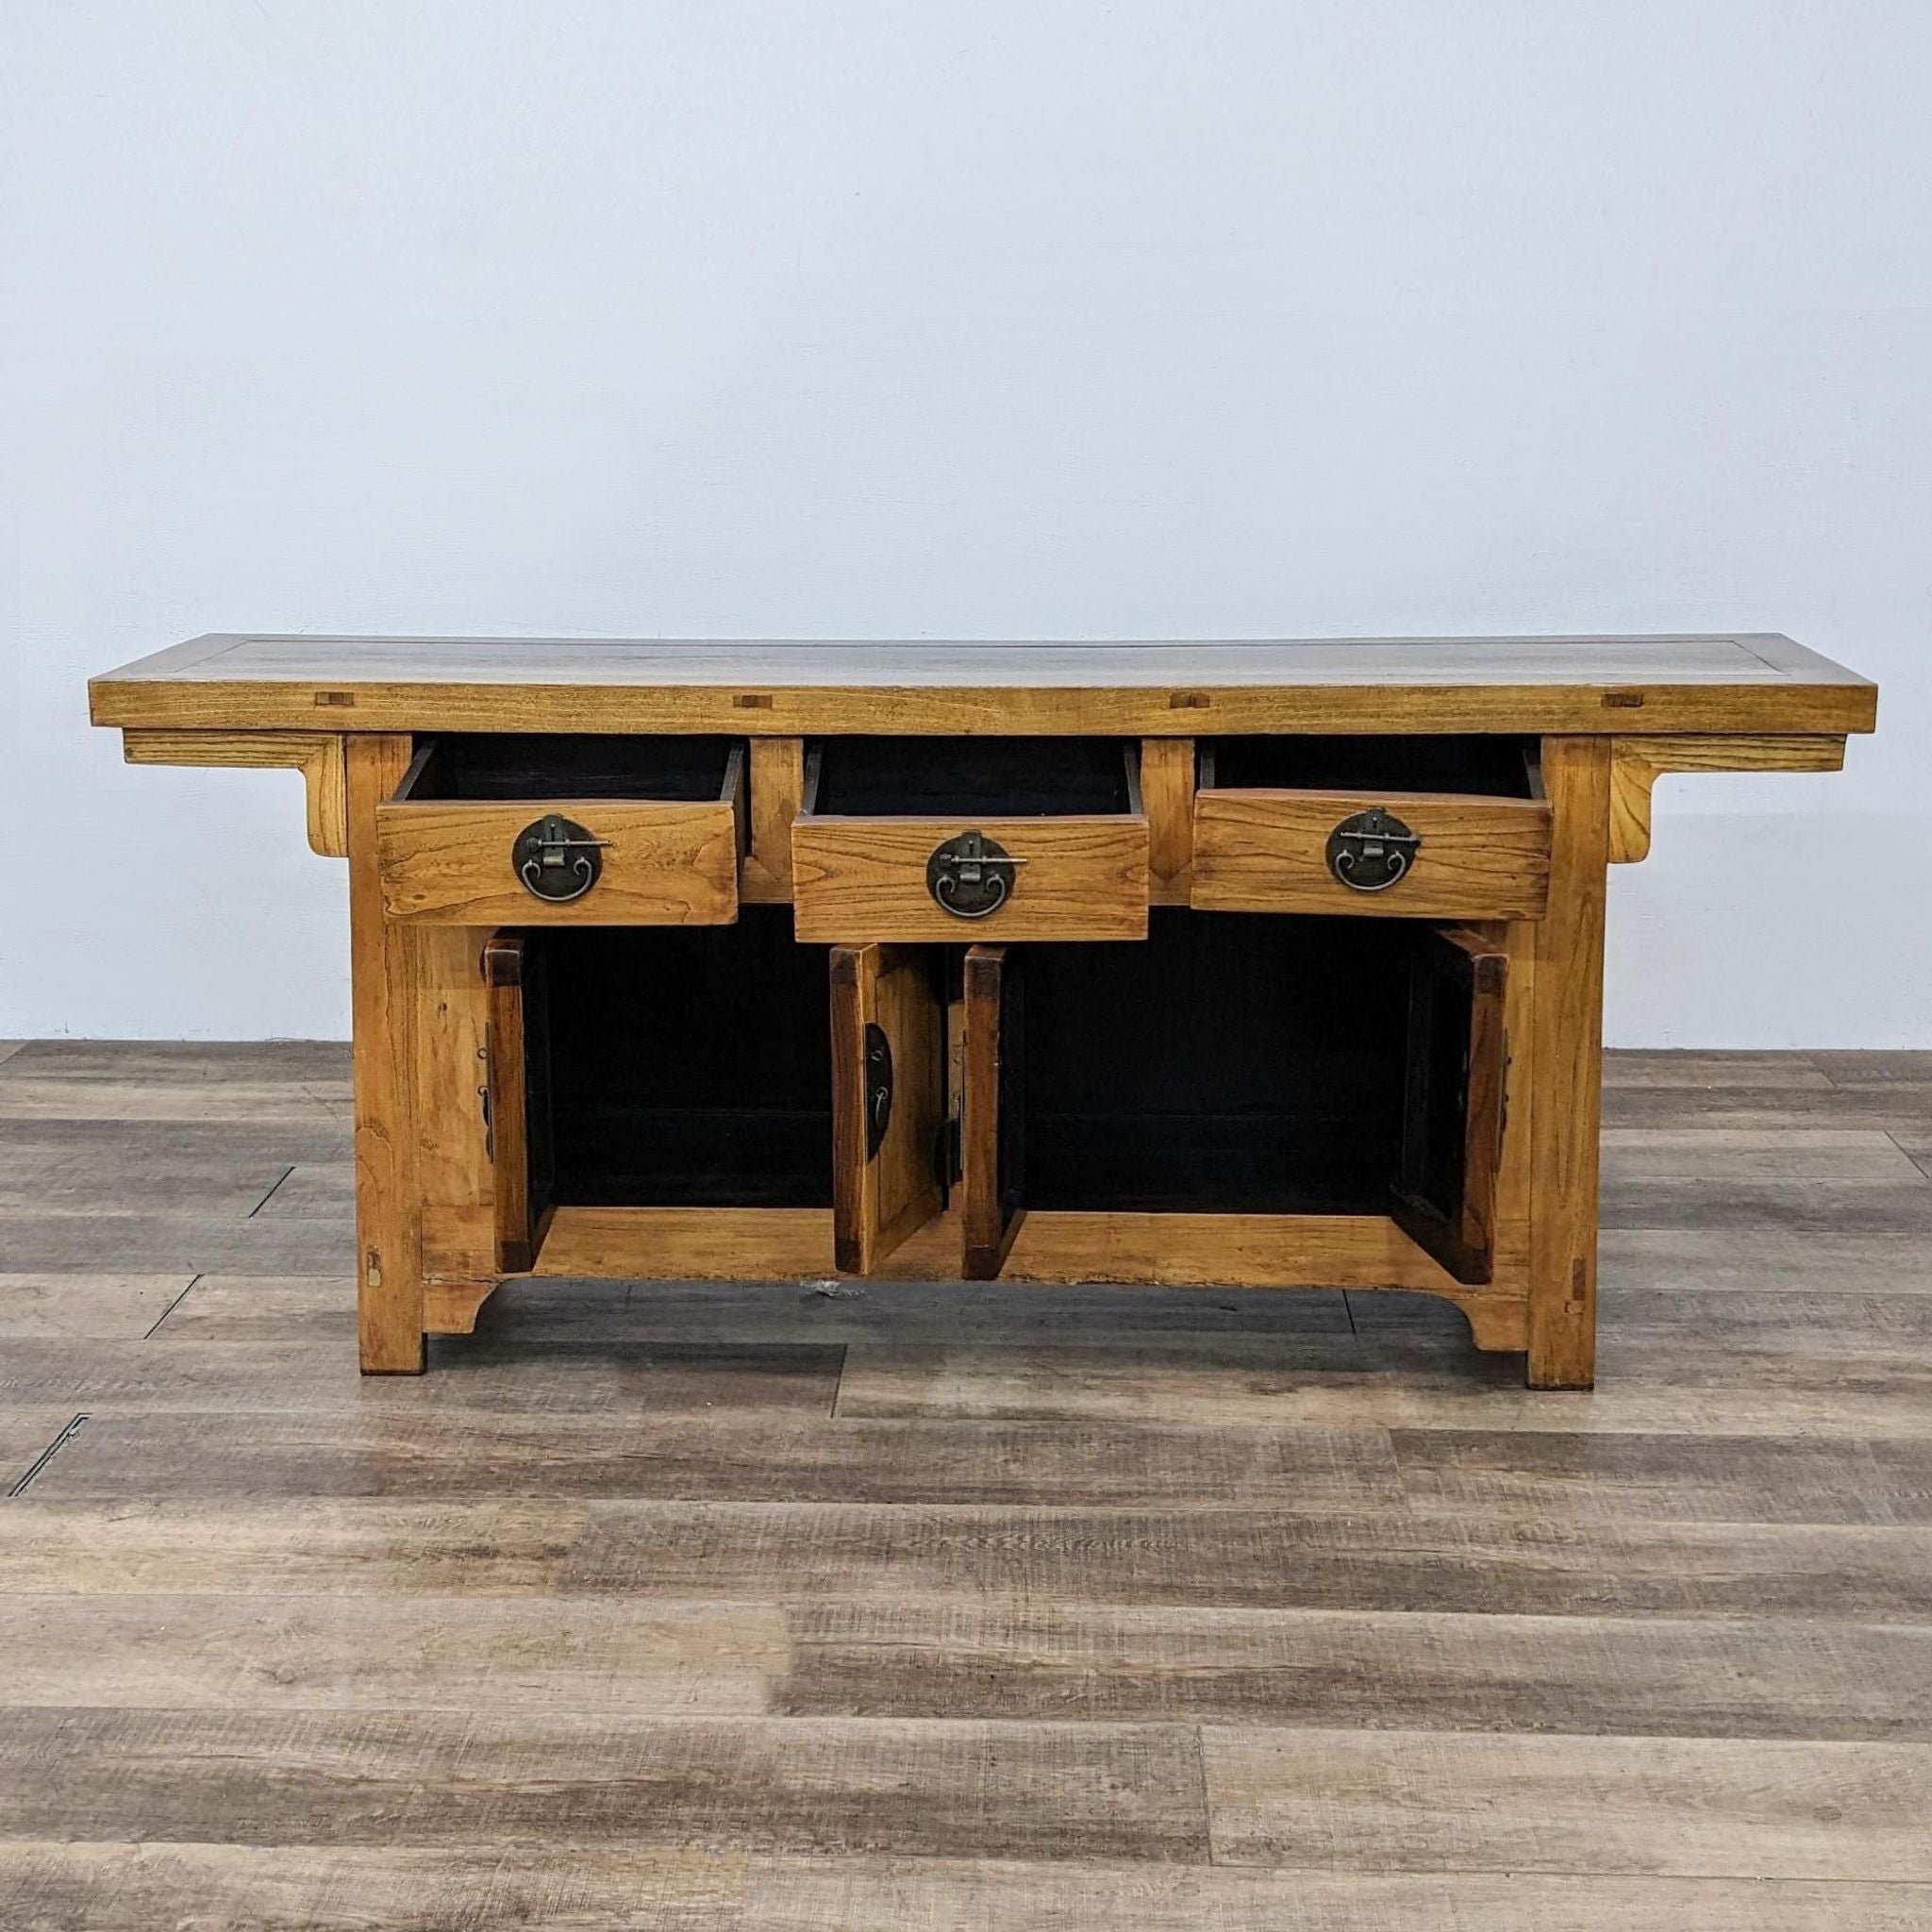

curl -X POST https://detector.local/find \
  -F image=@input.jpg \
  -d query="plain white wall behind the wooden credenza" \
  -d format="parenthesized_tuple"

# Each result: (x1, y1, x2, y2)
(0, 0, 1932, 1045)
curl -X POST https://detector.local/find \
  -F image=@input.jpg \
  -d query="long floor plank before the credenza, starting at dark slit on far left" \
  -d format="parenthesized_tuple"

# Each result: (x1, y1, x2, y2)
(29, 1406, 1403, 1507)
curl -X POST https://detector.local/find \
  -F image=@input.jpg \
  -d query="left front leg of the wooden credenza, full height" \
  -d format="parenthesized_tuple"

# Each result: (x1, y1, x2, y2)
(348, 734, 425, 1375)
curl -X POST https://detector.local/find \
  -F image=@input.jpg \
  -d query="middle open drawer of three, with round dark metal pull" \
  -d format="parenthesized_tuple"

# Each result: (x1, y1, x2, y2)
(792, 738, 1148, 942)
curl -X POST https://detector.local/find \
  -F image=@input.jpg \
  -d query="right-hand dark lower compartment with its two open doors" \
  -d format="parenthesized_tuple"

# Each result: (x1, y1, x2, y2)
(958, 910, 1508, 1285)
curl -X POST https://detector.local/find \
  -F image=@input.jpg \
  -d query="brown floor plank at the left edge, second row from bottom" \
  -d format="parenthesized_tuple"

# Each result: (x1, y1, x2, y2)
(0, 1707, 1208, 1862)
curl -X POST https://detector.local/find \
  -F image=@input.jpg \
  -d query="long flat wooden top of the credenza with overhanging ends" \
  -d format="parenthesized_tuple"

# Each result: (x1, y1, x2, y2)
(89, 632, 1878, 736)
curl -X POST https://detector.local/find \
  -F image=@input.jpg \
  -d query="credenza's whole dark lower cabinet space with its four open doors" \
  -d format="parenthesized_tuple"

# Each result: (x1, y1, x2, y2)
(485, 907, 1507, 1281)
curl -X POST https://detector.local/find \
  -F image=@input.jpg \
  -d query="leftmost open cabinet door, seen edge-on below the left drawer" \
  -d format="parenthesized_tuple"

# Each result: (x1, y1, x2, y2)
(483, 933, 555, 1275)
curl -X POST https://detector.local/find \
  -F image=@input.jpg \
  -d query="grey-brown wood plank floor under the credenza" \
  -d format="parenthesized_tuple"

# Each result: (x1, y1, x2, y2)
(0, 1041, 1932, 1932)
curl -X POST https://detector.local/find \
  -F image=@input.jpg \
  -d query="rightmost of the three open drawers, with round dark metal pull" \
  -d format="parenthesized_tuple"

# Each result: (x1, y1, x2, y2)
(1192, 738, 1549, 920)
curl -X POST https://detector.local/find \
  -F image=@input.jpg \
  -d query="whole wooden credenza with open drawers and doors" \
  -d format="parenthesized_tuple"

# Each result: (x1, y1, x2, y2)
(91, 636, 1876, 1387)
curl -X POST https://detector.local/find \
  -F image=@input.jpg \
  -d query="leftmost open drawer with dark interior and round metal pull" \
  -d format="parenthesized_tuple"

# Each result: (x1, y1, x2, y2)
(376, 736, 746, 925)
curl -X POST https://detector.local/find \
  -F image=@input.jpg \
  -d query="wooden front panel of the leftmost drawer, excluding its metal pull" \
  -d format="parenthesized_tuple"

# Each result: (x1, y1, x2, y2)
(376, 798, 740, 925)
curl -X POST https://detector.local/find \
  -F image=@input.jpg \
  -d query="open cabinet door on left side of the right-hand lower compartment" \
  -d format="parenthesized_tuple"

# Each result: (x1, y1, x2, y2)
(960, 947, 1025, 1281)
